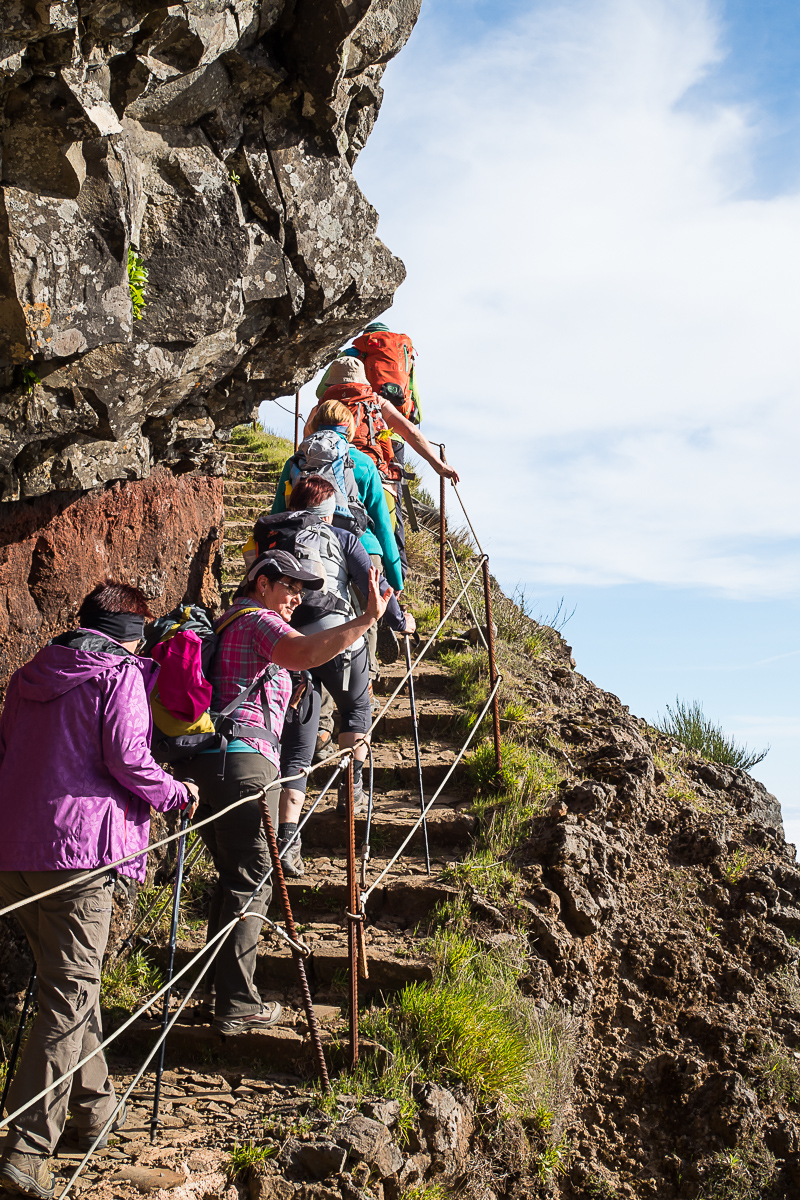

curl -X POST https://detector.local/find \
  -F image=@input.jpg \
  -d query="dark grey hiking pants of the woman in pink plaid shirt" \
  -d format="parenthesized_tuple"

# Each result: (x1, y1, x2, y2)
(181, 754, 281, 1020)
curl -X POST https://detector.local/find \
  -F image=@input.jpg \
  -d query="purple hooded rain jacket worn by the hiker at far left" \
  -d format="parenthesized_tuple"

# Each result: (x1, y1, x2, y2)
(0, 644, 187, 882)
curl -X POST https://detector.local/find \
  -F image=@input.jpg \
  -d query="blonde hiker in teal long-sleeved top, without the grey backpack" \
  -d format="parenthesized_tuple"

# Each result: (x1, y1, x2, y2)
(271, 401, 403, 592)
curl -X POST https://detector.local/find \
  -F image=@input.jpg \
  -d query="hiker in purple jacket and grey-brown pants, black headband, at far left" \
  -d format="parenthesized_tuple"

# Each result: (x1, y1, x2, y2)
(0, 580, 197, 1200)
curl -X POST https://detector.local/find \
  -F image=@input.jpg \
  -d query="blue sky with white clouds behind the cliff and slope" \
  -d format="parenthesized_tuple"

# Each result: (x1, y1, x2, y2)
(264, 0, 800, 842)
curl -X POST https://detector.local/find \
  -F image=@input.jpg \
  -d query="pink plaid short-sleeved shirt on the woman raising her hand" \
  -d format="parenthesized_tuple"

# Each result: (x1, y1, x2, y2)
(211, 599, 291, 769)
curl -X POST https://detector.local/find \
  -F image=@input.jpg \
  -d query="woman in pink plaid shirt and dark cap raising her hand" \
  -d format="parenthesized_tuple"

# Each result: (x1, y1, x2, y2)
(185, 550, 393, 1033)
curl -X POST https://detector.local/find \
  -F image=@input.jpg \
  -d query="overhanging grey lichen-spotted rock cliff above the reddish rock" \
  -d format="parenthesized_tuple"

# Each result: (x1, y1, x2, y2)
(0, 0, 420, 499)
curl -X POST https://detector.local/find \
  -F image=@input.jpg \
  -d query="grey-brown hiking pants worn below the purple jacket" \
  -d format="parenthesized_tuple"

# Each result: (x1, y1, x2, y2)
(0, 871, 116, 1157)
